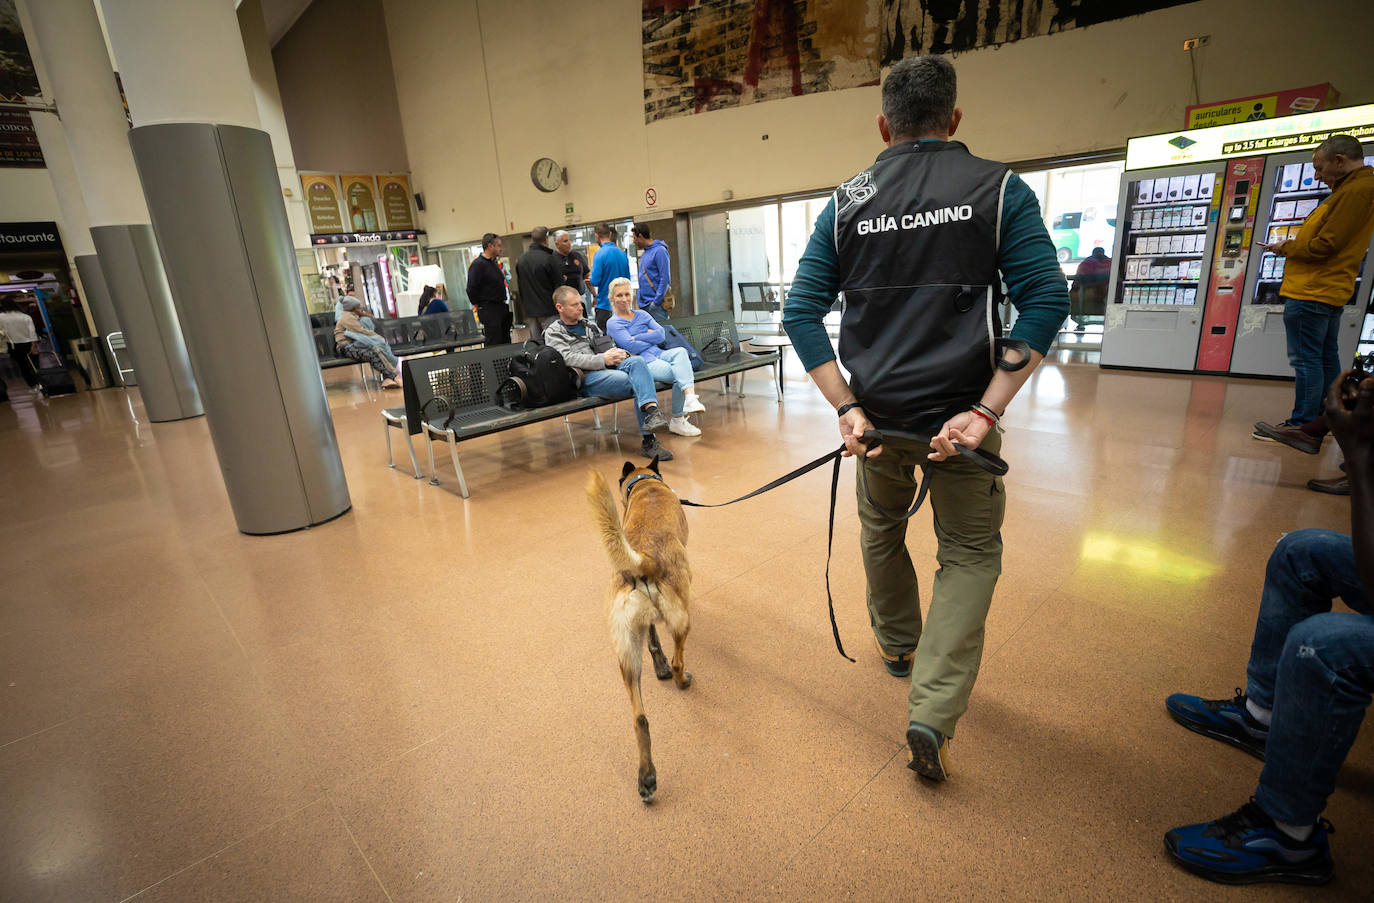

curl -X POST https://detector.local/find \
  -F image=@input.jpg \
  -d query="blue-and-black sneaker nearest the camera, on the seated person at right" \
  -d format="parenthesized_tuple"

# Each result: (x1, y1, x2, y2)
(1164, 799, 1334, 884)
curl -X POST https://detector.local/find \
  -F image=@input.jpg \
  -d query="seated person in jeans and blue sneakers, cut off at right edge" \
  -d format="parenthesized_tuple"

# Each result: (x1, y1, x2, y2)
(1164, 374, 1374, 884)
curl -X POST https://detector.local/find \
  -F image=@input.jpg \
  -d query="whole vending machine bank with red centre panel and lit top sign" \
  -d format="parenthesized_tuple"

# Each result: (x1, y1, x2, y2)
(1101, 104, 1374, 377)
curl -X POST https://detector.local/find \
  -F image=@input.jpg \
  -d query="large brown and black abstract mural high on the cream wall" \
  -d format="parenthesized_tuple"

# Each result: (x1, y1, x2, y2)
(642, 0, 1194, 122)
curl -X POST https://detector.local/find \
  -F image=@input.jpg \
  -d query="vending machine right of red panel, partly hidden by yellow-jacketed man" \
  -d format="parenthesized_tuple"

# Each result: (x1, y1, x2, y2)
(1230, 144, 1374, 377)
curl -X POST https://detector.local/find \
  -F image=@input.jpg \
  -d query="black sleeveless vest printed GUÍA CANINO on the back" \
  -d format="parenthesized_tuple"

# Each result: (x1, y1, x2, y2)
(835, 142, 1010, 426)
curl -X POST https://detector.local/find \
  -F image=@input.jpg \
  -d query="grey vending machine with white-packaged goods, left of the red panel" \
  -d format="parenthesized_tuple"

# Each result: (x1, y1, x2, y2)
(1101, 162, 1223, 370)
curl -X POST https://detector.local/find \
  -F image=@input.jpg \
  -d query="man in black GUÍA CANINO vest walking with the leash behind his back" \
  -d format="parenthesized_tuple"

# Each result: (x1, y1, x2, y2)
(783, 56, 1069, 781)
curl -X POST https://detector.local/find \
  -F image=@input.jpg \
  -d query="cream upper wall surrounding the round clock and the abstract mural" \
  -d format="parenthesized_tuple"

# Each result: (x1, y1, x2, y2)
(376, 0, 1374, 245)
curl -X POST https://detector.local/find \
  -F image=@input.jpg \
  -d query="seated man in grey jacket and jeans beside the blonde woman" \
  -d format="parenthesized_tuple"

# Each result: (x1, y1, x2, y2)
(544, 286, 673, 460)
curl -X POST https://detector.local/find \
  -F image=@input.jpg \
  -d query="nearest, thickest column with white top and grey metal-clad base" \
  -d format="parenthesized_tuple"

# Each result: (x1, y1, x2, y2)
(102, 0, 350, 533)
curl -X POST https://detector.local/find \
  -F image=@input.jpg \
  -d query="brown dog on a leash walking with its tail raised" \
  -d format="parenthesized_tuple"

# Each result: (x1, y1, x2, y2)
(587, 458, 691, 803)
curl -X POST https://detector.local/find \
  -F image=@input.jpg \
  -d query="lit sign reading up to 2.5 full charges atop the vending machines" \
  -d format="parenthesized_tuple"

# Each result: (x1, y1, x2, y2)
(1125, 103, 1374, 169)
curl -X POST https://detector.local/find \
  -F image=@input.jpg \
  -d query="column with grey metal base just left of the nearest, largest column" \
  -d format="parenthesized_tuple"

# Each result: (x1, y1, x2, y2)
(21, 0, 203, 422)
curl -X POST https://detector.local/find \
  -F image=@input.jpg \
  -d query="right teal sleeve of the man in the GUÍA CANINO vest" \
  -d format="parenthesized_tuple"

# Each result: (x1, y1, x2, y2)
(998, 173, 1069, 355)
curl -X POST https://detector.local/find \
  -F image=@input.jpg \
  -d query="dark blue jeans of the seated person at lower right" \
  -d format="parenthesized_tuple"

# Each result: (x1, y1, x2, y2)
(1246, 529, 1374, 825)
